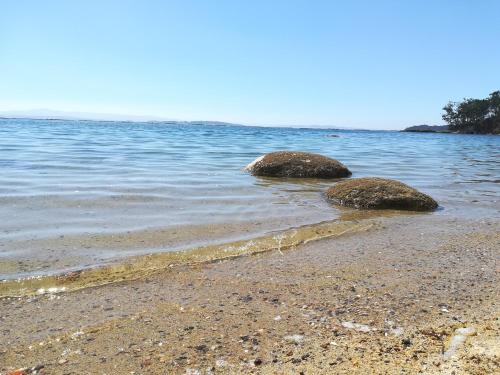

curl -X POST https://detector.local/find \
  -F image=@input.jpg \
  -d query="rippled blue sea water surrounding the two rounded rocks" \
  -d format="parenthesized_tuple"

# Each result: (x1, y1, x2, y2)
(0, 120, 500, 279)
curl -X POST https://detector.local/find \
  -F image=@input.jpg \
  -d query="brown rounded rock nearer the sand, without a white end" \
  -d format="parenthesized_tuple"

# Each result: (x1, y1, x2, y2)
(326, 177, 438, 211)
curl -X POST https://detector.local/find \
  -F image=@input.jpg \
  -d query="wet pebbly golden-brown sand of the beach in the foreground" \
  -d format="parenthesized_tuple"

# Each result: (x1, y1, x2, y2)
(0, 215, 500, 374)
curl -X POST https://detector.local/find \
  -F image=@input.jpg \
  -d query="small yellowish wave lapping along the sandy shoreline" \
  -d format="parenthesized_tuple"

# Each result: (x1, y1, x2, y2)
(0, 220, 375, 298)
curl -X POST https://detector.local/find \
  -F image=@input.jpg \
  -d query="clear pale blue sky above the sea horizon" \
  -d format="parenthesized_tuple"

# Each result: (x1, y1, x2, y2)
(0, 0, 500, 129)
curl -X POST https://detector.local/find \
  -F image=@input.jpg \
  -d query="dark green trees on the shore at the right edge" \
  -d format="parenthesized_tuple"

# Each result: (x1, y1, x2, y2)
(442, 91, 500, 134)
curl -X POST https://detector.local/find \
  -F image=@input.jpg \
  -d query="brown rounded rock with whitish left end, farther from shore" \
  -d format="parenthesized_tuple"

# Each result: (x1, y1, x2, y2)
(245, 151, 351, 178)
